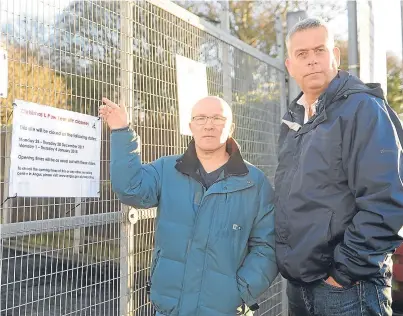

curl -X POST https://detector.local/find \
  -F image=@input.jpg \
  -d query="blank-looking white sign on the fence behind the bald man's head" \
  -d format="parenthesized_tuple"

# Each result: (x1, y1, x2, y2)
(176, 55, 208, 136)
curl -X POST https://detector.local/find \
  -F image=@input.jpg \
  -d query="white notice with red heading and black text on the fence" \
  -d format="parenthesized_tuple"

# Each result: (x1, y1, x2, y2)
(9, 100, 101, 197)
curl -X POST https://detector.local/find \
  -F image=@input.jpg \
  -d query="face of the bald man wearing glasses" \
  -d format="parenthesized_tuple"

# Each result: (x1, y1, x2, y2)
(190, 99, 233, 151)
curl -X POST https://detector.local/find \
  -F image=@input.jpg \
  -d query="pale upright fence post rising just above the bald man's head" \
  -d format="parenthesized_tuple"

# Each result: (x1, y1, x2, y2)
(220, 0, 232, 104)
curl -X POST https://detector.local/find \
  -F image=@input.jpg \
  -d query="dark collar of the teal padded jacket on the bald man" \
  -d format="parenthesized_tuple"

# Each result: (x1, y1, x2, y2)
(175, 138, 249, 179)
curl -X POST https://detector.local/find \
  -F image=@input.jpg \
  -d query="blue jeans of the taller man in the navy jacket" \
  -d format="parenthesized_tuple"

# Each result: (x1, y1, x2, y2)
(287, 281, 392, 316)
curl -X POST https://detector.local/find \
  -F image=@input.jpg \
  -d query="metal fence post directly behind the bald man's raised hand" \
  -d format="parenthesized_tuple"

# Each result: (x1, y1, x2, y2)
(119, 1, 135, 316)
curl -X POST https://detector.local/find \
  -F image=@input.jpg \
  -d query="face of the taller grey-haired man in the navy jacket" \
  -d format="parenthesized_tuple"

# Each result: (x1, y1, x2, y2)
(286, 27, 340, 93)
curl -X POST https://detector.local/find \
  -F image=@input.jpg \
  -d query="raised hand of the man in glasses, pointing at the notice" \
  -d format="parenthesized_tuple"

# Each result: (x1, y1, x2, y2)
(99, 98, 129, 130)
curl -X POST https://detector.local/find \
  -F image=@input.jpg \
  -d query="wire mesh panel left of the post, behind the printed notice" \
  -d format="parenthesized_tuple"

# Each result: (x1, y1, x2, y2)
(0, 0, 122, 315)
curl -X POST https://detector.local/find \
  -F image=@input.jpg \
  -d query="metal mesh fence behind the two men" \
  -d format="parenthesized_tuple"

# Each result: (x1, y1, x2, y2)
(0, 0, 285, 316)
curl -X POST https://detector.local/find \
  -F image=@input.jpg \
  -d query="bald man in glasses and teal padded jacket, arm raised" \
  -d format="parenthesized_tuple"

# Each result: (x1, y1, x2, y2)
(100, 97, 278, 316)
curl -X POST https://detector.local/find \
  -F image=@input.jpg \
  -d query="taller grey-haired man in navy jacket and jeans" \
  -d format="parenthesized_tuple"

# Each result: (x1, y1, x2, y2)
(275, 18, 403, 316)
